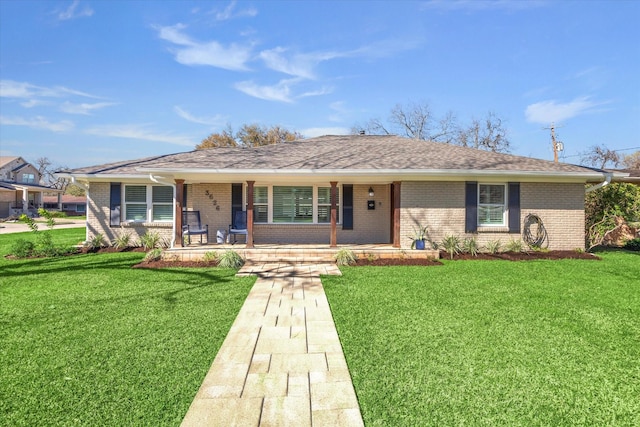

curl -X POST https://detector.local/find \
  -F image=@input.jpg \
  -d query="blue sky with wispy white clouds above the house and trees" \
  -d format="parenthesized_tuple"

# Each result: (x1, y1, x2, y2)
(0, 0, 640, 167)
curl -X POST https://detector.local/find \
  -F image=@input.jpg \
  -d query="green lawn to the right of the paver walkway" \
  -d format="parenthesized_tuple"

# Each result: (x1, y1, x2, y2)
(323, 252, 640, 426)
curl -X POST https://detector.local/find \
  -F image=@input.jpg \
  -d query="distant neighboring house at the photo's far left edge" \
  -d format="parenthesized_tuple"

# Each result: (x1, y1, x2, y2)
(0, 156, 60, 218)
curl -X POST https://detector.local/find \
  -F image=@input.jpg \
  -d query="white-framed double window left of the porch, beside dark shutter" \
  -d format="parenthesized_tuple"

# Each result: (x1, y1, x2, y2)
(124, 185, 173, 222)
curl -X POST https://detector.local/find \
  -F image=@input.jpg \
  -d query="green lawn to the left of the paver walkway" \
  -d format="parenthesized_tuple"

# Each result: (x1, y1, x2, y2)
(0, 228, 255, 426)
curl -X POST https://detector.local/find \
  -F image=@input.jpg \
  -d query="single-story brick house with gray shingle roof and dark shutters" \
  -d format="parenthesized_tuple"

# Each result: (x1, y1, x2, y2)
(60, 135, 624, 250)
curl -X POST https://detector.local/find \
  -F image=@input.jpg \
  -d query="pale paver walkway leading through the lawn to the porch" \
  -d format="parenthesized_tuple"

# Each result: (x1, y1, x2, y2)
(182, 264, 364, 427)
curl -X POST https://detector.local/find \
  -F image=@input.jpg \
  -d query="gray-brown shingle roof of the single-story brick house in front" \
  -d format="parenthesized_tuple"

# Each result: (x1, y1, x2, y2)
(63, 135, 604, 181)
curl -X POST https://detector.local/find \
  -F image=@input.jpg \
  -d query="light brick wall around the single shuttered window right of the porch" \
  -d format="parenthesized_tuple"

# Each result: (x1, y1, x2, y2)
(400, 182, 584, 250)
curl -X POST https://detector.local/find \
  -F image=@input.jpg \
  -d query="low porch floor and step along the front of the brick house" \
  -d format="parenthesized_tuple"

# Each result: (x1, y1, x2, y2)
(165, 243, 439, 263)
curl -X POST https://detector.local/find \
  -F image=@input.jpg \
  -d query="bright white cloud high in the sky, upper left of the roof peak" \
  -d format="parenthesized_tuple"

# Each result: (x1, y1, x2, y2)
(157, 24, 252, 71)
